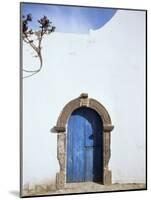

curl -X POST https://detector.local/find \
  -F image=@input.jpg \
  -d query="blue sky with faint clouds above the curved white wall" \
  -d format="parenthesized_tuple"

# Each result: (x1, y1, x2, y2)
(21, 3, 117, 33)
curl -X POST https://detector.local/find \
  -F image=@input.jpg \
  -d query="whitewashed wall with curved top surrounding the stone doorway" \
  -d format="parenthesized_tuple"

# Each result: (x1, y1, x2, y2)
(23, 10, 145, 184)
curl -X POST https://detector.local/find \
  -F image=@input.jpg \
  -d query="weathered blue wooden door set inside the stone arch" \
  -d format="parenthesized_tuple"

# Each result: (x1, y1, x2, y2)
(67, 107, 103, 182)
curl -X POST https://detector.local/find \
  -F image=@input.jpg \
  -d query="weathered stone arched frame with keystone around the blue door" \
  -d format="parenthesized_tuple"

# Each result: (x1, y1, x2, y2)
(53, 93, 114, 189)
